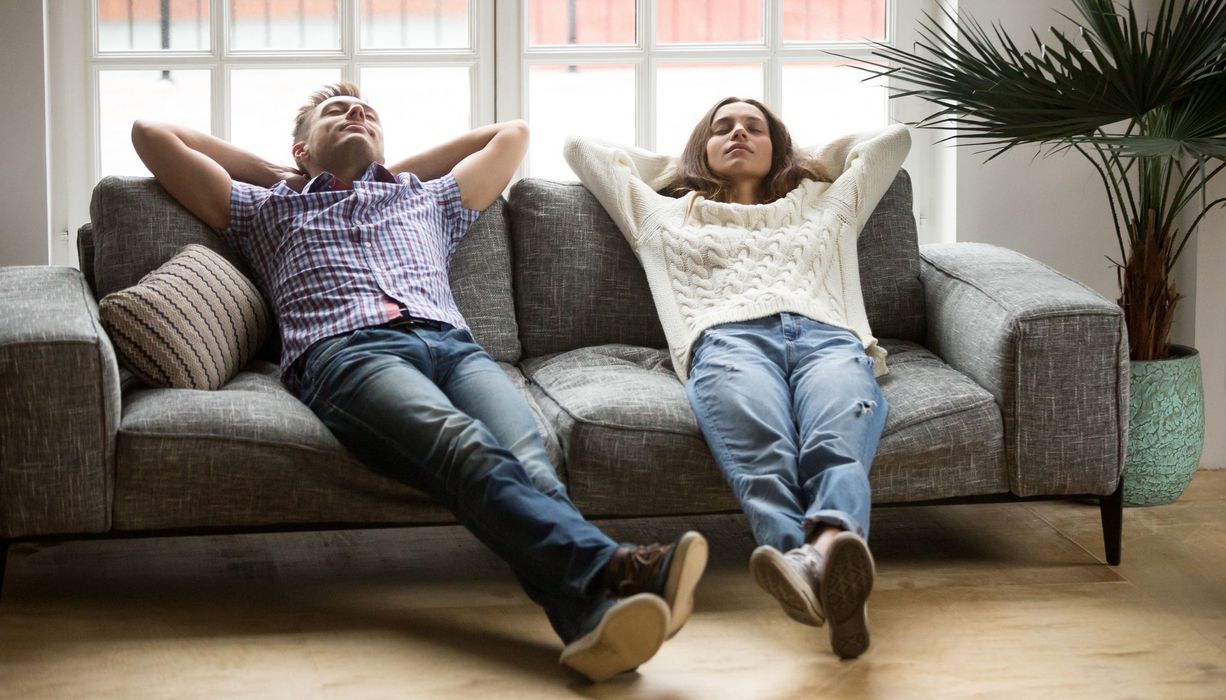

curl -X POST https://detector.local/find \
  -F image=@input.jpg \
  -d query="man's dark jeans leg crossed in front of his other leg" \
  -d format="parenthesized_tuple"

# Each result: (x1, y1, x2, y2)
(296, 329, 617, 642)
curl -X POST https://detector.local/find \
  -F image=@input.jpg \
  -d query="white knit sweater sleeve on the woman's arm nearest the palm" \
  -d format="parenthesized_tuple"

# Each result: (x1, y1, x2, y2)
(813, 124, 911, 232)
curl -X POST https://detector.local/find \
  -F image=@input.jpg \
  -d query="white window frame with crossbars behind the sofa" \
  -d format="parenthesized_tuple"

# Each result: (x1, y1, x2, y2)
(47, 0, 936, 265)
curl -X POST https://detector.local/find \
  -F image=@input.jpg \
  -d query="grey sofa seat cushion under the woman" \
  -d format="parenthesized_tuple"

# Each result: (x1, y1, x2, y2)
(524, 340, 1009, 517)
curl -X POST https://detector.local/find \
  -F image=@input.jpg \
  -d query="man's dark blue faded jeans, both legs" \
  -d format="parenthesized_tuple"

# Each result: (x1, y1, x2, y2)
(299, 324, 617, 642)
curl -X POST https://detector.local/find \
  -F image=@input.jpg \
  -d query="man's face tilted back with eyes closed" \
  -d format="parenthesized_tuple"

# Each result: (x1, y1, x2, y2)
(293, 96, 384, 170)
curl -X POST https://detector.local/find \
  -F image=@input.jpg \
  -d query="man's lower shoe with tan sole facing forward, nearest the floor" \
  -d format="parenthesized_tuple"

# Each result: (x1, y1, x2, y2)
(562, 593, 668, 683)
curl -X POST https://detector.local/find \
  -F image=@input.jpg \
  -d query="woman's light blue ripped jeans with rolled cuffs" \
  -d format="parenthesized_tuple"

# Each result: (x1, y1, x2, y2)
(685, 314, 889, 552)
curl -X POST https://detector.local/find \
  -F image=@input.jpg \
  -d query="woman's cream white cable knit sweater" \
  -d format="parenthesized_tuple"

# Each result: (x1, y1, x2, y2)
(565, 126, 911, 381)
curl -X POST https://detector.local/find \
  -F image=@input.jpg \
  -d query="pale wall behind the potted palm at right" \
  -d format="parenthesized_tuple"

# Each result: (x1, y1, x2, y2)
(954, 0, 1226, 468)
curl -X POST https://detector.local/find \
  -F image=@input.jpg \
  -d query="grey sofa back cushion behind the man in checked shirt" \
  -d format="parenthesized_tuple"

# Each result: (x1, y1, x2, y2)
(81, 177, 520, 362)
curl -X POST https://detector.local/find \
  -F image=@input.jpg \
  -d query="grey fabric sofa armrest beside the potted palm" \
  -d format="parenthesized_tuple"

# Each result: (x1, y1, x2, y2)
(920, 243, 1128, 496)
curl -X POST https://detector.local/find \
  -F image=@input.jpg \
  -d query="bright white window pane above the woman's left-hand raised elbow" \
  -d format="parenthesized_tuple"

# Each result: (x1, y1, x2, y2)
(528, 65, 635, 180)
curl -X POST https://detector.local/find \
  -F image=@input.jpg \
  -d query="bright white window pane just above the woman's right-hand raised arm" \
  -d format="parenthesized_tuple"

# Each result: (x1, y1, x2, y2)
(782, 64, 889, 146)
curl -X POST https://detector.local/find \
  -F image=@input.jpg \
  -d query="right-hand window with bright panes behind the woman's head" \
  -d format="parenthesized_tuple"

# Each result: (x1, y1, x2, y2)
(499, 0, 897, 179)
